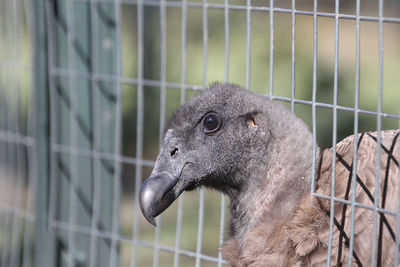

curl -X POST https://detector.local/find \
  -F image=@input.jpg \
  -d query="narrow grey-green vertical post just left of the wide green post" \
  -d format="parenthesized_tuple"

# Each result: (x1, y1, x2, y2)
(32, 0, 55, 267)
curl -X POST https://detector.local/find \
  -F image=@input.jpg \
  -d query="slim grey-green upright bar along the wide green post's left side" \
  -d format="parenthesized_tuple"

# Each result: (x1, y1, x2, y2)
(31, 0, 56, 266)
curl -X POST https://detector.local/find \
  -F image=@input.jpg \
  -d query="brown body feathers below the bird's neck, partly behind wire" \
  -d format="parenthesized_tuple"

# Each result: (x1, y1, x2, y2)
(223, 130, 400, 266)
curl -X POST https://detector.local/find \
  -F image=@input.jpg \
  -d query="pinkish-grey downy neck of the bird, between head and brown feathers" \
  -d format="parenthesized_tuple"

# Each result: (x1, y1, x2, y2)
(229, 139, 312, 240)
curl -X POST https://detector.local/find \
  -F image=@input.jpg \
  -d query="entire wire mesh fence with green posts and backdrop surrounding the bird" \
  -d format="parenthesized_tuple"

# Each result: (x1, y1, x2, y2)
(0, 0, 400, 267)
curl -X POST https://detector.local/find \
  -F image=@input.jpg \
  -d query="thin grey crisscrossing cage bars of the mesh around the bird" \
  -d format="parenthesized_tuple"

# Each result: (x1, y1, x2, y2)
(0, 0, 400, 266)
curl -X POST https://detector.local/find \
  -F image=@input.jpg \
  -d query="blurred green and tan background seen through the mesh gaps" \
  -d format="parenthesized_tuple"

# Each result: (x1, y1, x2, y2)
(0, 0, 400, 266)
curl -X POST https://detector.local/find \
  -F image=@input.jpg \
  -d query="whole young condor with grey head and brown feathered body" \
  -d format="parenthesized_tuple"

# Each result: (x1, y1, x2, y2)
(139, 83, 400, 266)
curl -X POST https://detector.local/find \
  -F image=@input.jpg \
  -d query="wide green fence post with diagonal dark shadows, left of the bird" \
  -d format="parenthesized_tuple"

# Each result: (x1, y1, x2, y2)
(47, 1, 121, 267)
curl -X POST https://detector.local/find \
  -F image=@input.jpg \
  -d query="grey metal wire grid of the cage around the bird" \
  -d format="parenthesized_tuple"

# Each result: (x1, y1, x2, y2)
(0, 0, 400, 266)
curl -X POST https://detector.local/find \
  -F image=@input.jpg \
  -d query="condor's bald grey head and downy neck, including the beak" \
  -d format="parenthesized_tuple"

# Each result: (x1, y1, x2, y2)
(139, 83, 312, 237)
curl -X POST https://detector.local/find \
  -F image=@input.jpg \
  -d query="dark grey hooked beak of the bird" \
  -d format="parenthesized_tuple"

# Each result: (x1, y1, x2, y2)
(139, 172, 181, 226)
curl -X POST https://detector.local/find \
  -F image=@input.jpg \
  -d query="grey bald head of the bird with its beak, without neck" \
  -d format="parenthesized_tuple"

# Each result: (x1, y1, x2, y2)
(139, 83, 314, 225)
